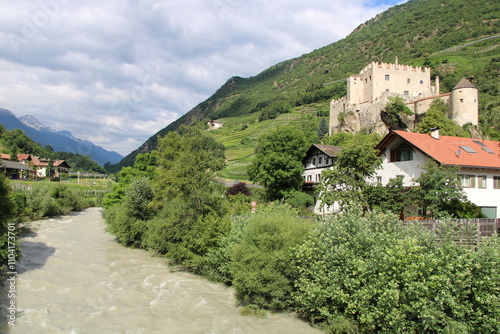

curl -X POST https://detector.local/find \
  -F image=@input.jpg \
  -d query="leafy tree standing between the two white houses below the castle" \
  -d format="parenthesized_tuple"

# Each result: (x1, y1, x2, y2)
(318, 137, 382, 210)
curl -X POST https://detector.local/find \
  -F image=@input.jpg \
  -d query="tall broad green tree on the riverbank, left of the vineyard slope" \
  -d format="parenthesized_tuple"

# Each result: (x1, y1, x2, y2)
(143, 128, 228, 270)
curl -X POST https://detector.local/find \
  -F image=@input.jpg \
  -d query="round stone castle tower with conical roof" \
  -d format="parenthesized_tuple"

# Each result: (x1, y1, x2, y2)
(448, 78, 479, 126)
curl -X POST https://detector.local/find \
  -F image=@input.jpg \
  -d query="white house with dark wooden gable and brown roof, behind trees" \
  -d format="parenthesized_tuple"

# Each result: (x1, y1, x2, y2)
(302, 144, 342, 214)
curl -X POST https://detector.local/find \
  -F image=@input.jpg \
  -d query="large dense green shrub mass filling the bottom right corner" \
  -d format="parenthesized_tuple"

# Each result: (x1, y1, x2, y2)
(293, 212, 500, 333)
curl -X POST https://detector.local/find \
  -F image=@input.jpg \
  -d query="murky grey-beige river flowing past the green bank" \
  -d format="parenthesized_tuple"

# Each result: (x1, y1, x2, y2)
(2, 208, 320, 334)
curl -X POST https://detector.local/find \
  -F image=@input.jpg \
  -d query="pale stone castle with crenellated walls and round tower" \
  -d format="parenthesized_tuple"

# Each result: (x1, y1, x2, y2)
(329, 57, 478, 135)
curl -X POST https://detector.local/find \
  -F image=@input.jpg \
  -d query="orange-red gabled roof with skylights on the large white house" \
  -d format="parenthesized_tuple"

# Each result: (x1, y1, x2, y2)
(376, 130, 500, 169)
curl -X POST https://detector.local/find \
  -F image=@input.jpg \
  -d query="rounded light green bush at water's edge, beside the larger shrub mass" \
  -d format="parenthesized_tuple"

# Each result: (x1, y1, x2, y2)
(230, 206, 311, 310)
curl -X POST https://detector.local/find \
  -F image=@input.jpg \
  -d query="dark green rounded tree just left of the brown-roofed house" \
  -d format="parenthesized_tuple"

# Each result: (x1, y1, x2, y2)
(248, 127, 308, 200)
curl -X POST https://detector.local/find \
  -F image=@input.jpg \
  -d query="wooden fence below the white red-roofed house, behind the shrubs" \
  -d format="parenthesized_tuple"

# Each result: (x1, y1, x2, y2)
(403, 218, 500, 244)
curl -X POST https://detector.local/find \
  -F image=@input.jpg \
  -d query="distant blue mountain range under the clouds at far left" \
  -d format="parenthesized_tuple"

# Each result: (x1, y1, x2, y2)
(0, 108, 123, 166)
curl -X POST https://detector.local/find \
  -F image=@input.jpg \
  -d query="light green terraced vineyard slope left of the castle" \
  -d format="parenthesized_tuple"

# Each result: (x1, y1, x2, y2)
(207, 102, 329, 182)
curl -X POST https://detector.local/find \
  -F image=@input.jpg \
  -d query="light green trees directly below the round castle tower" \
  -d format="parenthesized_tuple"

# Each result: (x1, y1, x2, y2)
(417, 99, 470, 137)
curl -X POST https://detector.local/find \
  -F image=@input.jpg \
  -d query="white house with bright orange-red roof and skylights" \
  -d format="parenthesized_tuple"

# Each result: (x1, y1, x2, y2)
(375, 130, 500, 218)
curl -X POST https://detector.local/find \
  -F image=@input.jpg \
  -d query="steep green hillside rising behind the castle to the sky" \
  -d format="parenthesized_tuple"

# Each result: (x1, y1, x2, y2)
(112, 0, 500, 175)
